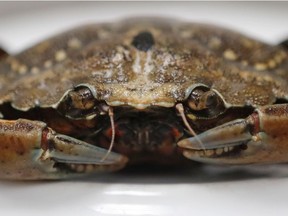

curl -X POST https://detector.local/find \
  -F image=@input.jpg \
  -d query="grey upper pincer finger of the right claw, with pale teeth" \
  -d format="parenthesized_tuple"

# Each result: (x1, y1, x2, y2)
(177, 119, 252, 157)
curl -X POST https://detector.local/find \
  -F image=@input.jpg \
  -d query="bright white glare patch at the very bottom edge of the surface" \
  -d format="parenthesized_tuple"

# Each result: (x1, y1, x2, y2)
(93, 203, 167, 216)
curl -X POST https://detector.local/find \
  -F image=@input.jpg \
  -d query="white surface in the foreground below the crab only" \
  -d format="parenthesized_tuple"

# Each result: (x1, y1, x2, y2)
(0, 165, 288, 216)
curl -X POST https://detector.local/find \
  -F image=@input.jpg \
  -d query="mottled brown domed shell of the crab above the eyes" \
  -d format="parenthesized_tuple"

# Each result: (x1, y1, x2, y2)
(0, 19, 288, 110)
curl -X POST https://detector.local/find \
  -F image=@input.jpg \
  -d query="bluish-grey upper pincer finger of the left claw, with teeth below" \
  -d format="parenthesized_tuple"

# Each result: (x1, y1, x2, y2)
(38, 129, 128, 180)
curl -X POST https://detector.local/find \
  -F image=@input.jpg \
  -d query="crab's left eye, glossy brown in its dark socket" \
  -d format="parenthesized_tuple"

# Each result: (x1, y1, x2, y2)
(57, 86, 105, 119)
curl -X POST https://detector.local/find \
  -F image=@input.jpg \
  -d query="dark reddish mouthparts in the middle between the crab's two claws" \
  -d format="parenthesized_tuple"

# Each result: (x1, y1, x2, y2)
(91, 107, 184, 165)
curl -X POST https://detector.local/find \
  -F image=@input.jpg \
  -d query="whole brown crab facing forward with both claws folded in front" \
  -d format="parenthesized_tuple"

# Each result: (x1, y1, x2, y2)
(0, 18, 288, 180)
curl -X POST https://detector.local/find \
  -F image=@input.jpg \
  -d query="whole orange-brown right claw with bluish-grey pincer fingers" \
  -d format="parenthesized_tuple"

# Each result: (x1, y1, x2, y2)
(178, 104, 288, 164)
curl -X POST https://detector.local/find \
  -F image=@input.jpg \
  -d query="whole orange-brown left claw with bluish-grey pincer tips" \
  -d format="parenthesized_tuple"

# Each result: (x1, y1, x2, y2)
(0, 119, 127, 179)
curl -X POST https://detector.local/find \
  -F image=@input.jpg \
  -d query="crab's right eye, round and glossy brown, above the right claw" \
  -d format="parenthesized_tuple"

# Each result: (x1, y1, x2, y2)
(187, 86, 225, 118)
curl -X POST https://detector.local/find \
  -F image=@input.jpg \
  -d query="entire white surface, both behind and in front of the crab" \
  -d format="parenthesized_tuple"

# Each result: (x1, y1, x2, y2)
(0, 2, 288, 216)
